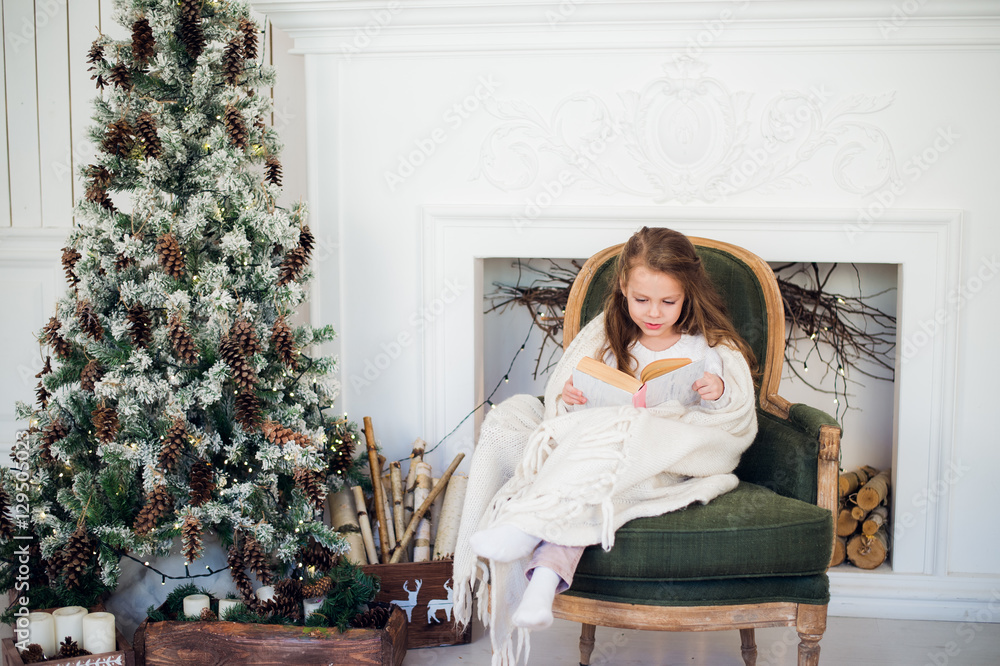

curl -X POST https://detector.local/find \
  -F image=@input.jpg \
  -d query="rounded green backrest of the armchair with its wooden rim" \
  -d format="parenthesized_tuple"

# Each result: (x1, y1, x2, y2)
(563, 232, 785, 414)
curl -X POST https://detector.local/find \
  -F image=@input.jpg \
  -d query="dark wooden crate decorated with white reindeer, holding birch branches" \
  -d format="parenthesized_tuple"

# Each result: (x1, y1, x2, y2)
(361, 560, 472, 648)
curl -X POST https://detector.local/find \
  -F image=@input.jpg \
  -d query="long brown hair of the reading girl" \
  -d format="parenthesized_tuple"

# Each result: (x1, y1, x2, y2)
(599, 227, 757, 376)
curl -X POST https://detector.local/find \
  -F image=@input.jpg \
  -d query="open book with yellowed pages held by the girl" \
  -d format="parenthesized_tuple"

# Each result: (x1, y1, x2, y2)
(573, 356, 705, 407)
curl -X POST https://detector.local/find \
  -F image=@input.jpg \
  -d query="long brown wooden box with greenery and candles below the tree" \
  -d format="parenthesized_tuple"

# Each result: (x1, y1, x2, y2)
(133, 608, 407, 666)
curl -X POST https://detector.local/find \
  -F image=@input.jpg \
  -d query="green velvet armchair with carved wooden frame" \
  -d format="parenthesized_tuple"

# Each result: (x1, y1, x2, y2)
(553, 238, 841, 666)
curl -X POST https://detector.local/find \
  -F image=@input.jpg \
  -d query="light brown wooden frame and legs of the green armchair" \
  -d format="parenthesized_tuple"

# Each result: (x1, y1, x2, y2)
(553, 237, 841, 666)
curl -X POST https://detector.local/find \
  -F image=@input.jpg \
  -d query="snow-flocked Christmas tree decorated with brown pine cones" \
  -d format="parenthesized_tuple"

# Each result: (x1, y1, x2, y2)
(0, 0, 366, 610)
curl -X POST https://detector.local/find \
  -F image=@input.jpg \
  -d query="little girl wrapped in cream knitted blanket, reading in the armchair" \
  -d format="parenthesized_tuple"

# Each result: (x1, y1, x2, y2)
(455, 228, 756, 664)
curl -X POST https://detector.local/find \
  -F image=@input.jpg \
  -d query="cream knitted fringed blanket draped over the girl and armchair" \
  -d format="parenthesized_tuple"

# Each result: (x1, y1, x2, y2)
(454, 315, 757, 666)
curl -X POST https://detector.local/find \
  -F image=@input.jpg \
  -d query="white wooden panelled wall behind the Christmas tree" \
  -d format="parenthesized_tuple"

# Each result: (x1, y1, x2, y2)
(0, 0, 306, 457)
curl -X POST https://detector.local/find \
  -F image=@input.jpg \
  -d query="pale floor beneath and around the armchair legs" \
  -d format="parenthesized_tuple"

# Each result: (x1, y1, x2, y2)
(403, 617, 1000, 666)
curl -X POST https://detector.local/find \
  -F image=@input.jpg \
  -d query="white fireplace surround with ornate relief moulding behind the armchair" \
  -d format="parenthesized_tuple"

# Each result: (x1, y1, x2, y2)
(253, 0, 1000, 621)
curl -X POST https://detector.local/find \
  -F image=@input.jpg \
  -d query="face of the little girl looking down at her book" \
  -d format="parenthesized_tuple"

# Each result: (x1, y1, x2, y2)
(622, 266, 684, 351)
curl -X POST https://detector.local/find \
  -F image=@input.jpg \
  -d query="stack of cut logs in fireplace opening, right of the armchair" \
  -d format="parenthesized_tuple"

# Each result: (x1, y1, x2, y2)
(830, 466, 892, 569)
